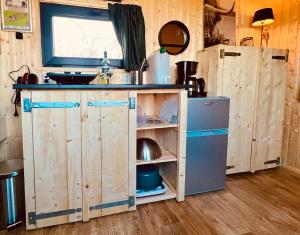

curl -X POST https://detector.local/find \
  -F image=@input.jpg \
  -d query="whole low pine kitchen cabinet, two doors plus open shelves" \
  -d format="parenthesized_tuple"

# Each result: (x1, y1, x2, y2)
(22, 89, 187, 229)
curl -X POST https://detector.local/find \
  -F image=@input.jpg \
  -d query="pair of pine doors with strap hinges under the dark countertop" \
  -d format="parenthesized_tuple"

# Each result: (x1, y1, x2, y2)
(22, 90, 136, 229)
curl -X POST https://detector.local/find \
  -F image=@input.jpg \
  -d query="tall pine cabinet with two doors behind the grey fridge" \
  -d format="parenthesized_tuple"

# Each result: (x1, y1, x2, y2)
(197, 45, 288, 173)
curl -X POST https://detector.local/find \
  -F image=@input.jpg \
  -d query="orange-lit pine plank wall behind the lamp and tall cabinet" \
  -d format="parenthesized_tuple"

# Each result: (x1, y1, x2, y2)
(237, 0, 300, 170)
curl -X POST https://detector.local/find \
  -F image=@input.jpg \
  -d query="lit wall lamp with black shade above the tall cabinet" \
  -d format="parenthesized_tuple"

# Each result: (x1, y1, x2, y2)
(252, 8, 274, 46)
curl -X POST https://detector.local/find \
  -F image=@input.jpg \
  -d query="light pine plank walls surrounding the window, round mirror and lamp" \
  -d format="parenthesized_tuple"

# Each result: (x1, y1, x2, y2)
(0, 0, 300, 173)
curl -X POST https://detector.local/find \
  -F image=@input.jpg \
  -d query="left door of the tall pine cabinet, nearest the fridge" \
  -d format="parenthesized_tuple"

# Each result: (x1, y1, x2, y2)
(216, 46, 258, 173)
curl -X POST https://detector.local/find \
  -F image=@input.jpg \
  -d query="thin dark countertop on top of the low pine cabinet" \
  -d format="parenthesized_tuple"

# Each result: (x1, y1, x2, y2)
(13, 84, 185, 90)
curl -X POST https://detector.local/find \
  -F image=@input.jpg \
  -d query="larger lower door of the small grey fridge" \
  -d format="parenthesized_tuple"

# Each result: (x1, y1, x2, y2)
(185, 131, 228, 195)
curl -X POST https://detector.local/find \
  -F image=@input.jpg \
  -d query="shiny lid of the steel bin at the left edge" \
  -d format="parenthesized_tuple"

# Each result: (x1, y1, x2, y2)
(0, 159, 23, 179)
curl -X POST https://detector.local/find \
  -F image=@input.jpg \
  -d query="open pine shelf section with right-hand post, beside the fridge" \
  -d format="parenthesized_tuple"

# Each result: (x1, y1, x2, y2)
(137, 90, 187, 204)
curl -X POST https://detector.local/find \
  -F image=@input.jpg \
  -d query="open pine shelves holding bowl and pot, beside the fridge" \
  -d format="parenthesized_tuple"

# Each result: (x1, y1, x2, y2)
(136, 90, 186, 205)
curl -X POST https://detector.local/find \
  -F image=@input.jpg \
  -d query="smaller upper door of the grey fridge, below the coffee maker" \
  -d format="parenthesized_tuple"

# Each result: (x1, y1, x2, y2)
(187, 98, 229, 131)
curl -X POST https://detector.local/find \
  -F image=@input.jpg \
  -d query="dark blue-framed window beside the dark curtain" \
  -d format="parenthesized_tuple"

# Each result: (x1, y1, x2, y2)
(40, 3, 123, 68)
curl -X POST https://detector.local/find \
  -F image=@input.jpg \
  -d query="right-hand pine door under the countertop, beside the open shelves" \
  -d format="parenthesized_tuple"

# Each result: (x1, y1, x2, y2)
(82, 91, 136, 221)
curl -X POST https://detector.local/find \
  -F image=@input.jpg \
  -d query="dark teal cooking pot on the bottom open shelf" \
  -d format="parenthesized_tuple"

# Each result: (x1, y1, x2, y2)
(136, 164, 162, 191)
